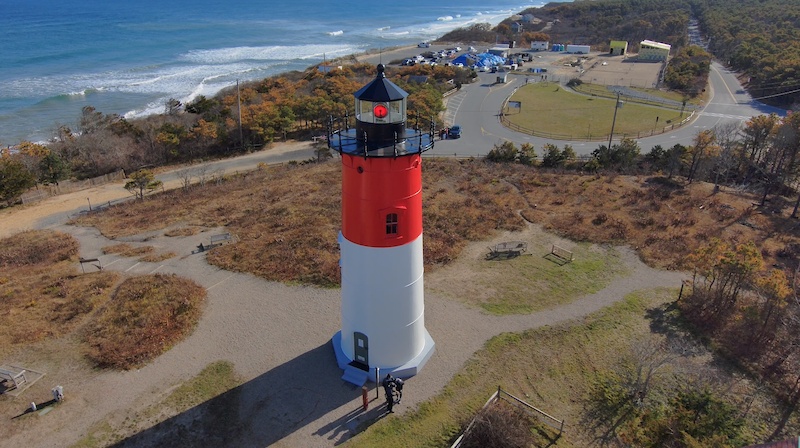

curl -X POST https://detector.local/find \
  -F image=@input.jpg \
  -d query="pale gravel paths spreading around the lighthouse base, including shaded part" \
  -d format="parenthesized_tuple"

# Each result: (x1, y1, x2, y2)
(0, 146, 682, 447)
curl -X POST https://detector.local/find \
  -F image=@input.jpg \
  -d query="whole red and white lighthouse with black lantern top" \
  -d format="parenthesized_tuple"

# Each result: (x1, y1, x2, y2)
(328, 65, 434, 385)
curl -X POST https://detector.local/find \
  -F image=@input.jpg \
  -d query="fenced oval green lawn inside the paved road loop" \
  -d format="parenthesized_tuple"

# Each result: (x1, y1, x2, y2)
(506, 83, 681, 139)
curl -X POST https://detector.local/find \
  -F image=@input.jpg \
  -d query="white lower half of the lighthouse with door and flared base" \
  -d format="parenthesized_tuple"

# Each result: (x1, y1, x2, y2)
(333, 234, 434, 384)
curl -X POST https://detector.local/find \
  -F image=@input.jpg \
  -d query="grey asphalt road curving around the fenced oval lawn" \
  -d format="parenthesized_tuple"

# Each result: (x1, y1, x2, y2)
(428, 62, 786, 156)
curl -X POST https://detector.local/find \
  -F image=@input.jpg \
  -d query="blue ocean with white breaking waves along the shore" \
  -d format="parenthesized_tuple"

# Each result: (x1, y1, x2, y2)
(0, 0, 543, 146)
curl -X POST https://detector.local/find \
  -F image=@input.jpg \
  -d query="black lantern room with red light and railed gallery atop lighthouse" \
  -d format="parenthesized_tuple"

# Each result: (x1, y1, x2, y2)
(328, 64, 434, 157)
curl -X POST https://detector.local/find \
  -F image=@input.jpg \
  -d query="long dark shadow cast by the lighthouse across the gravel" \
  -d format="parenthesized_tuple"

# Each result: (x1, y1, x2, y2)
(112, 342, 385, 447)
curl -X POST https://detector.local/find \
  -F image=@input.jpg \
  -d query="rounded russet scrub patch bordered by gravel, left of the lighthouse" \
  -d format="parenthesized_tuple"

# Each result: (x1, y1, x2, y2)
(85, 274, 206, 369)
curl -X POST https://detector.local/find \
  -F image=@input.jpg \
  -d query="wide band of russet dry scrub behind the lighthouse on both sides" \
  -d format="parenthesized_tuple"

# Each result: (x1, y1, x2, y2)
(76, 159, 798, 286)
